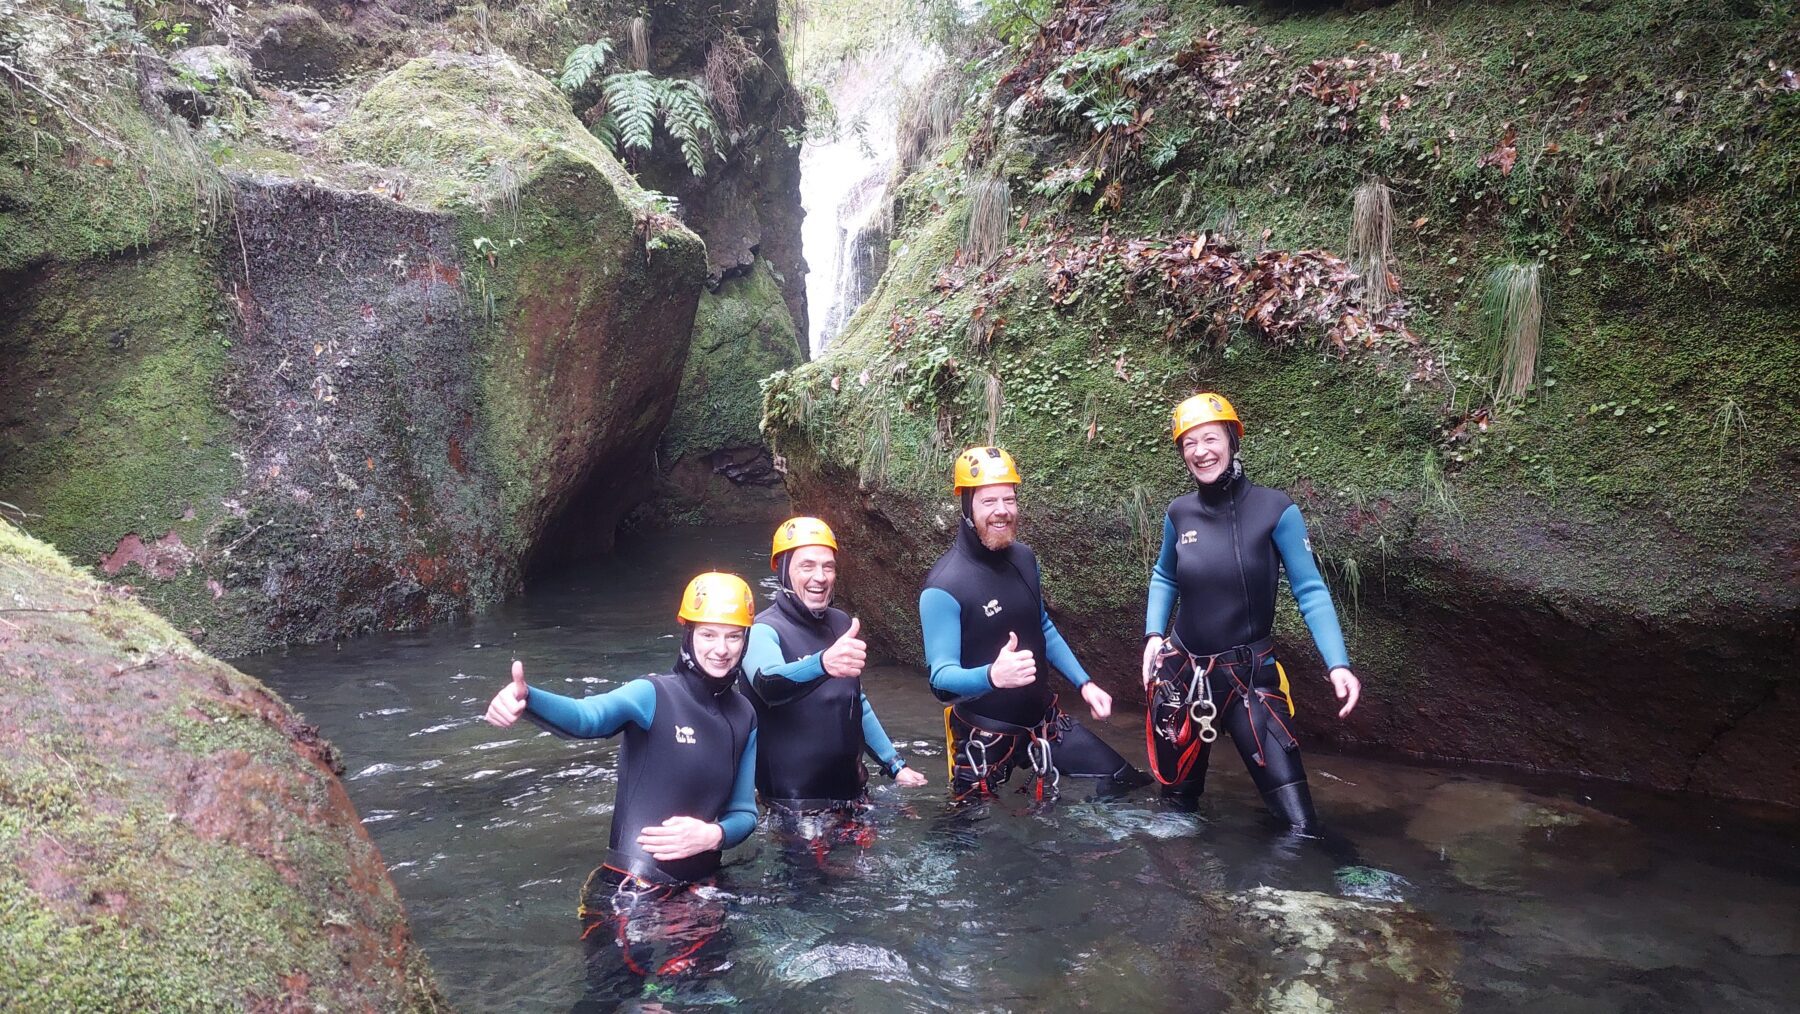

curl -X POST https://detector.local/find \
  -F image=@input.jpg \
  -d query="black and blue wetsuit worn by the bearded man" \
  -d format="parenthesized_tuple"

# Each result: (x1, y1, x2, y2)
(918, 515, 1147, 800)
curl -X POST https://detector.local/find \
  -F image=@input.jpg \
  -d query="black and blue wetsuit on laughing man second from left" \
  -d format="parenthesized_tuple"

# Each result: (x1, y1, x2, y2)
(743, 590, 905, 812)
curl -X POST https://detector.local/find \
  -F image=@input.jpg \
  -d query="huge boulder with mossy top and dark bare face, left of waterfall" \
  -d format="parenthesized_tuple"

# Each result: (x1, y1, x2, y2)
(0, 54, 706, 654)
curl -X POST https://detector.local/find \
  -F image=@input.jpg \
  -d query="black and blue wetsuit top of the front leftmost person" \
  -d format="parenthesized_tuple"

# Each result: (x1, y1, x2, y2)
(526, 659, 756, 886)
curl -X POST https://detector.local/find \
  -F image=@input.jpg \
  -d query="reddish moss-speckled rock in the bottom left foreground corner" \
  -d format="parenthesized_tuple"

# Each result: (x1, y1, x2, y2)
(0, 522, 441, 1010)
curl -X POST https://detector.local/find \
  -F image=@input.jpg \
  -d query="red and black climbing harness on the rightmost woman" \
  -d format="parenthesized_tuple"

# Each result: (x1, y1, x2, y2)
(1143, 638, 1300, 785)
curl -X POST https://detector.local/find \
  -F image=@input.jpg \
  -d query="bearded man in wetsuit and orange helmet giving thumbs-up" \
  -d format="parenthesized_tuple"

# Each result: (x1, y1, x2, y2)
(918, 447, 1148, 800)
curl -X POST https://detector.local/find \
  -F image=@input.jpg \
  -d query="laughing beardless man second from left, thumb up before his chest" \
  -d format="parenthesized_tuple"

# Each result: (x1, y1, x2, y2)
(743, 517, 925, 816)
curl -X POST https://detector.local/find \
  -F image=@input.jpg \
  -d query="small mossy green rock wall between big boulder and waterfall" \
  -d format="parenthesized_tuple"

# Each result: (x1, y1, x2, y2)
(659, 258, 801, 463)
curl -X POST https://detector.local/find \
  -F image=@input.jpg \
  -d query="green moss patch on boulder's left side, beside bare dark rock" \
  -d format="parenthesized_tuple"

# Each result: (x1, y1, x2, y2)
(0, 247, 239, 621)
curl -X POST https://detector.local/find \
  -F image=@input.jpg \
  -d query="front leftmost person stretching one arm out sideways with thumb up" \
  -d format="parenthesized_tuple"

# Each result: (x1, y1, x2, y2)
(486, 573, 756, 992)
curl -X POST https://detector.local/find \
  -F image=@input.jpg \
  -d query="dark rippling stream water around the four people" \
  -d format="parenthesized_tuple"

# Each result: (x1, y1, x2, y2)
(238, 528, 1800, 1012)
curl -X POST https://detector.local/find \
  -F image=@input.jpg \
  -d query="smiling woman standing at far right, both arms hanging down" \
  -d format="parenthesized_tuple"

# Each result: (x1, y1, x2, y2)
(1143, 393, 1361, 832)
